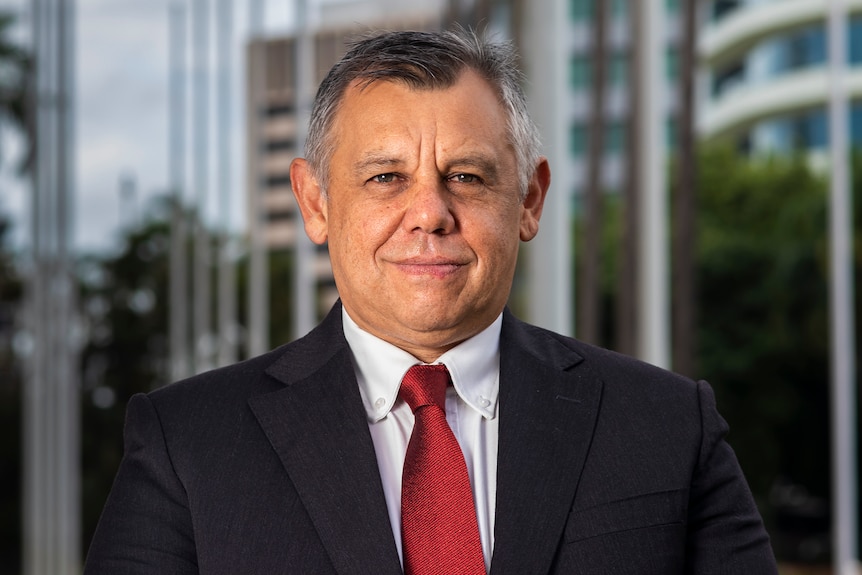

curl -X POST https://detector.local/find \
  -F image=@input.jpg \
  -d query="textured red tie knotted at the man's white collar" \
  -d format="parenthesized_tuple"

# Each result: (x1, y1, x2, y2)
(400, 365, 485, 575)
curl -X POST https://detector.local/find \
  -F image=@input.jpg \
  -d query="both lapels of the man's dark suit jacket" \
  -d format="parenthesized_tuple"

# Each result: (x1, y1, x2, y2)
(250, 304, 602, 575)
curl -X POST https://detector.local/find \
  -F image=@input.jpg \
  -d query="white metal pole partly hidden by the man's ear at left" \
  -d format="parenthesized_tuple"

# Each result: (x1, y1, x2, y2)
(293, 0, 317, 338)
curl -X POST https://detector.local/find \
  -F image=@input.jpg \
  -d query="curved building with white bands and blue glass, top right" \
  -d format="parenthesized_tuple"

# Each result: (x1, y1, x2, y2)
(698, 0, 862, 154)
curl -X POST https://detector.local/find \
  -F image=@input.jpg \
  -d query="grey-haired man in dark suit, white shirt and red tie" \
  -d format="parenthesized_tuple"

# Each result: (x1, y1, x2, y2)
(86, 28, 776, 575)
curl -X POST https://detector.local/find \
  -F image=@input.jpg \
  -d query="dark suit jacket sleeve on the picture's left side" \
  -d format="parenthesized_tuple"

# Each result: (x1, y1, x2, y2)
(84, 394, 198, 575)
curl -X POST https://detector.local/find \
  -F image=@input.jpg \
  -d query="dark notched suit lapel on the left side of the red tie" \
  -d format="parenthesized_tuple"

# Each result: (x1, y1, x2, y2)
(249, 306, 401, 575)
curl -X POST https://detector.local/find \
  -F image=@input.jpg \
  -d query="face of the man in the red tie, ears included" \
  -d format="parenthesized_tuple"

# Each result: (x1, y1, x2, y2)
(292, 71, 550, 361)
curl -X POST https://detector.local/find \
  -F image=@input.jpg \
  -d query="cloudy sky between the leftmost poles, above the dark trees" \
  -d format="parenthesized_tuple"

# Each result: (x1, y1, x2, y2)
(75, 0, 168, 250)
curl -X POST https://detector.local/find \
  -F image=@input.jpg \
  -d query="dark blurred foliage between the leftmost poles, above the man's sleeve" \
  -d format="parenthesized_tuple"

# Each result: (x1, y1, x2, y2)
(79, 200, 176, 552)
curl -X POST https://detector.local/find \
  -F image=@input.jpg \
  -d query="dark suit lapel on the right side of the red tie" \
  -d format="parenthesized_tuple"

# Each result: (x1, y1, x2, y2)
(491, 312, 602, 575)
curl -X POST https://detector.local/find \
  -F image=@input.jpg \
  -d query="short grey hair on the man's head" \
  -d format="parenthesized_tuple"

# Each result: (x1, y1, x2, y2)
(305, 29, 541, 199)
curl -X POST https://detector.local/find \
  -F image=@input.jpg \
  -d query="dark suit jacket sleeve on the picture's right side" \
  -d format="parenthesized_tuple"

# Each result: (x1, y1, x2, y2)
(686, 382, 778, 575)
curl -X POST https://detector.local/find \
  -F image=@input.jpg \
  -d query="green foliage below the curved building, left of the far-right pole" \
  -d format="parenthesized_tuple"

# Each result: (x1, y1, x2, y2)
(697, 149, 829, 504)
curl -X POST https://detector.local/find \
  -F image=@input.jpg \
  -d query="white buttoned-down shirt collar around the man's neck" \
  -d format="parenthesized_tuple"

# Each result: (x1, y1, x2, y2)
(342, 307, 503, 422)
